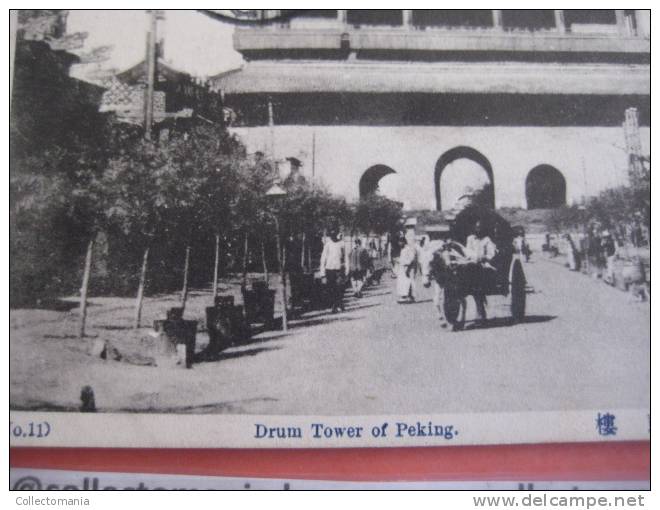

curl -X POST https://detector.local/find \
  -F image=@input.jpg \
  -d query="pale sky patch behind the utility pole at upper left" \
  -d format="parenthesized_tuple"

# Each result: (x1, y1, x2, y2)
(67, 10, 242, 77)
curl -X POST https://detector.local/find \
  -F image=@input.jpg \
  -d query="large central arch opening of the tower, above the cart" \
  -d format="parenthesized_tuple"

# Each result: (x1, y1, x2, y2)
(434, 146, 495, 211)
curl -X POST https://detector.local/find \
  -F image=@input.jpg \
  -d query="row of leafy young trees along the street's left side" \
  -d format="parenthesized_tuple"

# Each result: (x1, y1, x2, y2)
(11, 114, 401, 324)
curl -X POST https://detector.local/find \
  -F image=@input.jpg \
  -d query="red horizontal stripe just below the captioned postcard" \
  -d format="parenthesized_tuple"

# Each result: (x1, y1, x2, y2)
(10, 441, 651, 481)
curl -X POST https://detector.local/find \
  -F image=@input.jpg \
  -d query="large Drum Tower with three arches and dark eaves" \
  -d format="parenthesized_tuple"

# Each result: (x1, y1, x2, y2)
(212, 10, 650, 209)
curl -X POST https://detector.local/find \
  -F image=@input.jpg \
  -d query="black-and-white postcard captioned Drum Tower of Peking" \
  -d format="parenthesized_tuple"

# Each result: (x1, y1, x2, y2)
(9, 9, 651, 448)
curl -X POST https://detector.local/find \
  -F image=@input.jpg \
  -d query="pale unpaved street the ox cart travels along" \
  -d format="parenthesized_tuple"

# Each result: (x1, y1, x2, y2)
(11, 258, 650, 415)
